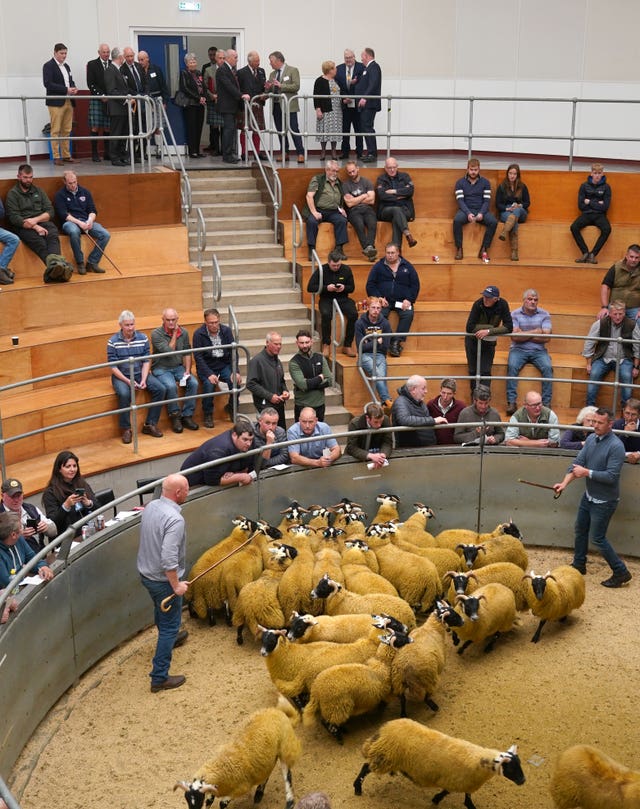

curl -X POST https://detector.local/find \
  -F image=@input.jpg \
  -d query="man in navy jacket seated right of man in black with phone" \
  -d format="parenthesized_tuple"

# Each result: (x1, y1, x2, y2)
(367, 242, 420, 357)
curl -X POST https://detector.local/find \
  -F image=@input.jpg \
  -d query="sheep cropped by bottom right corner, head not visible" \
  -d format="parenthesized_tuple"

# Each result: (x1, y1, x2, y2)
(549, 744, 640, 809)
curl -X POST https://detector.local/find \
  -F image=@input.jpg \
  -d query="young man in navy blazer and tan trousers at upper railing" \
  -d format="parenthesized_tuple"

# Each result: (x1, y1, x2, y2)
(42, 42, 78, 166)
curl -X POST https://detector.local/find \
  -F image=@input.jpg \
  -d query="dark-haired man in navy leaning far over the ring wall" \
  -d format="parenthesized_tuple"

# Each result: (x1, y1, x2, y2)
(180, 418, 256, 486)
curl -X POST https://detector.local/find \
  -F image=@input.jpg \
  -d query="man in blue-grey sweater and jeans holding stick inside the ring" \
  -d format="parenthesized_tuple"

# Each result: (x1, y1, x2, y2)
(553, 407, 631, 587)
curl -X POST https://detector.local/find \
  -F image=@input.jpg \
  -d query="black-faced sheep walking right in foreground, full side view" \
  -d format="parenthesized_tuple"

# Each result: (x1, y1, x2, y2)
(353, 719, 525, 809)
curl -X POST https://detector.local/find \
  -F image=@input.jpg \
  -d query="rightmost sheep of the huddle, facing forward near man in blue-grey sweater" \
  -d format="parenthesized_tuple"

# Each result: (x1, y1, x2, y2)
(523, 565, 585, 643)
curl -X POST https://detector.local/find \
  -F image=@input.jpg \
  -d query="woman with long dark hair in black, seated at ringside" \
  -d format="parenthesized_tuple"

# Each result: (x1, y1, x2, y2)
(42, 449, 96, 536)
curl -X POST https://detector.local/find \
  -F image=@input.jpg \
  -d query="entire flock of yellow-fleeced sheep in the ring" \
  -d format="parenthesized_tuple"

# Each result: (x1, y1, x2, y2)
(176, 494, 640, 809)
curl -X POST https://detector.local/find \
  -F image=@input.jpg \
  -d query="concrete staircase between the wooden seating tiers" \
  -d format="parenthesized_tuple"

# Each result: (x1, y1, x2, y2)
(189, 169, 351, 431)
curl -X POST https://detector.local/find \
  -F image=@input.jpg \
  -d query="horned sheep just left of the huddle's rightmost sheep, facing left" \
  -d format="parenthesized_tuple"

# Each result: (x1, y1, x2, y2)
(453, 582, 516, 655)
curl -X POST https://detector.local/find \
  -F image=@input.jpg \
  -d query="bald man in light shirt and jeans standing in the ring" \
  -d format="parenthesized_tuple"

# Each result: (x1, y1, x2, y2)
(137, 475, 189, 694)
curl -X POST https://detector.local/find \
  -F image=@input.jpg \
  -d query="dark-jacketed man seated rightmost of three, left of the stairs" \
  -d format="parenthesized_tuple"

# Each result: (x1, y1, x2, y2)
(193, 309, 242, 428)
